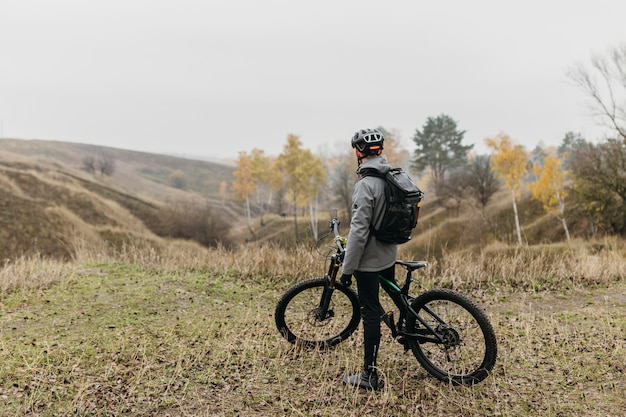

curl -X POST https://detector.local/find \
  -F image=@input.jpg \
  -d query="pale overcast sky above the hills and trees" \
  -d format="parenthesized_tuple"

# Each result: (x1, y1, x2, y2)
(0, 0, 626, 159)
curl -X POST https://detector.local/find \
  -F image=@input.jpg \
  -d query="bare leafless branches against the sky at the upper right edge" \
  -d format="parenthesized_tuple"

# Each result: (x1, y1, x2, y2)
(567, 43, 626, 143)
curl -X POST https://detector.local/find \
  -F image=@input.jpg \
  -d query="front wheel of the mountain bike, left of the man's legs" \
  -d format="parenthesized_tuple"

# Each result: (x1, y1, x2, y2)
(274, 277, 361, 348)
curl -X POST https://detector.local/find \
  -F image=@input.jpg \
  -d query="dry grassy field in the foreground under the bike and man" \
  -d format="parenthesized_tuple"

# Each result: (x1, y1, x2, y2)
(0, 242, 626, 417)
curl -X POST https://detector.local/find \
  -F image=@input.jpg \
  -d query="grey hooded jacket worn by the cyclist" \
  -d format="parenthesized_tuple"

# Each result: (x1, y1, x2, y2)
(342, 156, 398, 274)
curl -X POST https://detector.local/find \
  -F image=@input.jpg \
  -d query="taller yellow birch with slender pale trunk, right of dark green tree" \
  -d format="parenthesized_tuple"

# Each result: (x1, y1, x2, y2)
(486, 134, 528, 245)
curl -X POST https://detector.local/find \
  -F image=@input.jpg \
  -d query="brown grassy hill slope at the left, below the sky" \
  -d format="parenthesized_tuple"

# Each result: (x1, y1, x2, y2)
(0, 139, 241, 261)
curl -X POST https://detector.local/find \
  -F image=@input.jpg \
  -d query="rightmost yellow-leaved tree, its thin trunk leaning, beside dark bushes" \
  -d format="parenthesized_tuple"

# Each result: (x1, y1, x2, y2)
(530, 155, 570, 242)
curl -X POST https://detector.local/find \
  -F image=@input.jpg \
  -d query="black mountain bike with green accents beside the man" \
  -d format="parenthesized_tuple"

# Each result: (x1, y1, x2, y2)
(274, 212, 497, 385)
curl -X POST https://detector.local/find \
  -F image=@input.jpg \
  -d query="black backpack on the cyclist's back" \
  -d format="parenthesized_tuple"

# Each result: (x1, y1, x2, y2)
(360, 168, 424, 244)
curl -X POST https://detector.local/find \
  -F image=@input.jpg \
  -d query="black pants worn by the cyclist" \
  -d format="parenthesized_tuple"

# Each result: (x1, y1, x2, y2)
(354, 266, 398, 369)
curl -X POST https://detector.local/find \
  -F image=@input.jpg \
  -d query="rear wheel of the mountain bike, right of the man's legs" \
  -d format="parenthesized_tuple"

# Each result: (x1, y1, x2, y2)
(406, 288, 498, 385)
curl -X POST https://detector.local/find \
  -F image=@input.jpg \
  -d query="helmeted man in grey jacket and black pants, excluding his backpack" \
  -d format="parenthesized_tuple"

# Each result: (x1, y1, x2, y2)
(341, 129, 398, 390)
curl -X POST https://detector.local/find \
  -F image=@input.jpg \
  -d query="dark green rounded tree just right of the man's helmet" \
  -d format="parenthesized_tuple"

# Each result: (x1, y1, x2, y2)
(413, 114, 474, 195)
